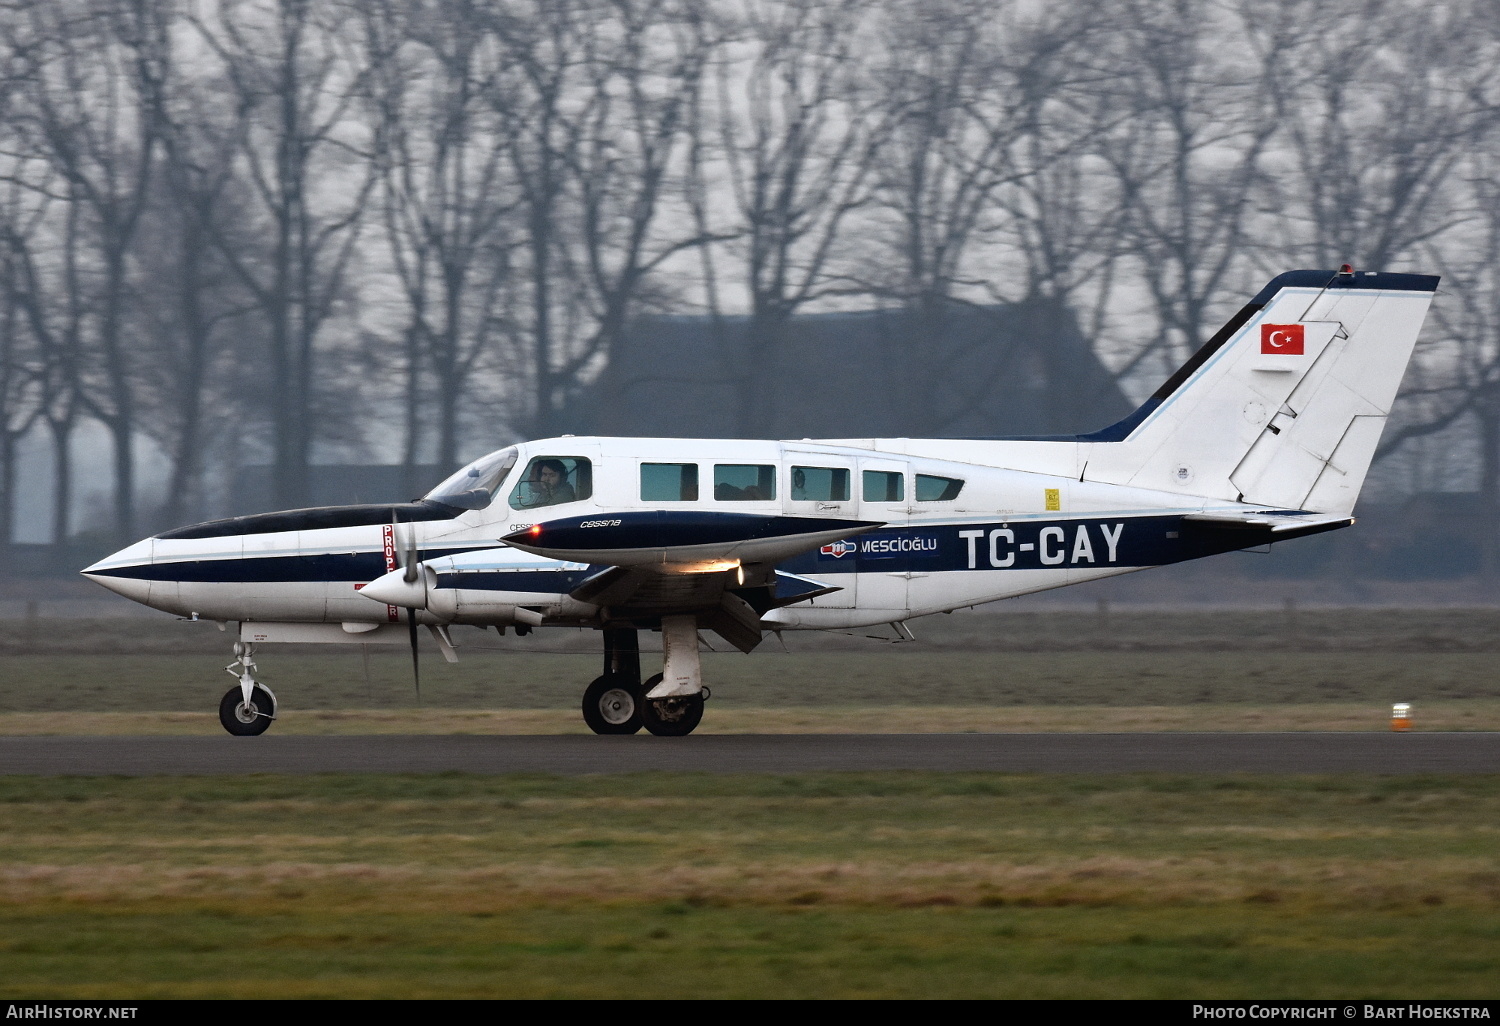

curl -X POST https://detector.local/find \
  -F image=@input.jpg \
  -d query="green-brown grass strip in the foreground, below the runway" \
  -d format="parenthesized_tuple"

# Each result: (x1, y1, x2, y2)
(0, 773, 1500, 998)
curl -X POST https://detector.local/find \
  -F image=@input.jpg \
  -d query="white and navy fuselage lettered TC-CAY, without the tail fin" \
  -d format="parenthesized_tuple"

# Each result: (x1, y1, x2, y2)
(86, 437, 1278, 630)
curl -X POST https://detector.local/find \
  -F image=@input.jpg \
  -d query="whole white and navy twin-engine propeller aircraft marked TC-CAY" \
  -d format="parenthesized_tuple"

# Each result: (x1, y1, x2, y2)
(83, 266, 1439, 735)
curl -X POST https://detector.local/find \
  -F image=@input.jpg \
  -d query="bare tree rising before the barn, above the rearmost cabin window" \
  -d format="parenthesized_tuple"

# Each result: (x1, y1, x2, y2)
(866, 0, 1119, 432)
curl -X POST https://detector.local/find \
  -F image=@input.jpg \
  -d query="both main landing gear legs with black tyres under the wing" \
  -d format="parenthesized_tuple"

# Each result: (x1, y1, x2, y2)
(584, 617, 708, 738)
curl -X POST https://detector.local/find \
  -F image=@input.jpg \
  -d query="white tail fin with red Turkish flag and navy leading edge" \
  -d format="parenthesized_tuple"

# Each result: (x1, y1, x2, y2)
(1080, 270, 1439, 516)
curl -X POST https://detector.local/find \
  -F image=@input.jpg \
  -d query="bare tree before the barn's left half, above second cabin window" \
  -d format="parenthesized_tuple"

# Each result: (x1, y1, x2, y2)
(705, 0, 884, 435)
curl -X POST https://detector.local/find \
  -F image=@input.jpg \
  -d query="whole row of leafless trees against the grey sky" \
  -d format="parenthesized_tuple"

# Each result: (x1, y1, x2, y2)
(0, 0, 1500, 549)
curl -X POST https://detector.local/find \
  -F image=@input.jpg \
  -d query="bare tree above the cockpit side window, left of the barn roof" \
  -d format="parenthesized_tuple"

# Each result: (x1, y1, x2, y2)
(491, 0, 716, 435)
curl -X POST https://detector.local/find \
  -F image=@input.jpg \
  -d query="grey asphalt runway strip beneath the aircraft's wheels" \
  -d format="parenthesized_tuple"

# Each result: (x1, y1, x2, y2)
(0, 734, 1500, 777)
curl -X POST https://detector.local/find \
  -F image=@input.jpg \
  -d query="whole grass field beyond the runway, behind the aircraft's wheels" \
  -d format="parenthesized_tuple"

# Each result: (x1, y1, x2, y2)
(0, 609, 1500, 732)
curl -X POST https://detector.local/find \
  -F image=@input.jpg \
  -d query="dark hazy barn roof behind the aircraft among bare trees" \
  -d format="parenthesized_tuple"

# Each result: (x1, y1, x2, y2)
(570, 303, 1133, 438)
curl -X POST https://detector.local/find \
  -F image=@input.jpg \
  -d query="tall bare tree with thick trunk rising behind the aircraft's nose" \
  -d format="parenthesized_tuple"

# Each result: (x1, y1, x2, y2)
(191, 0, 377, 507)
